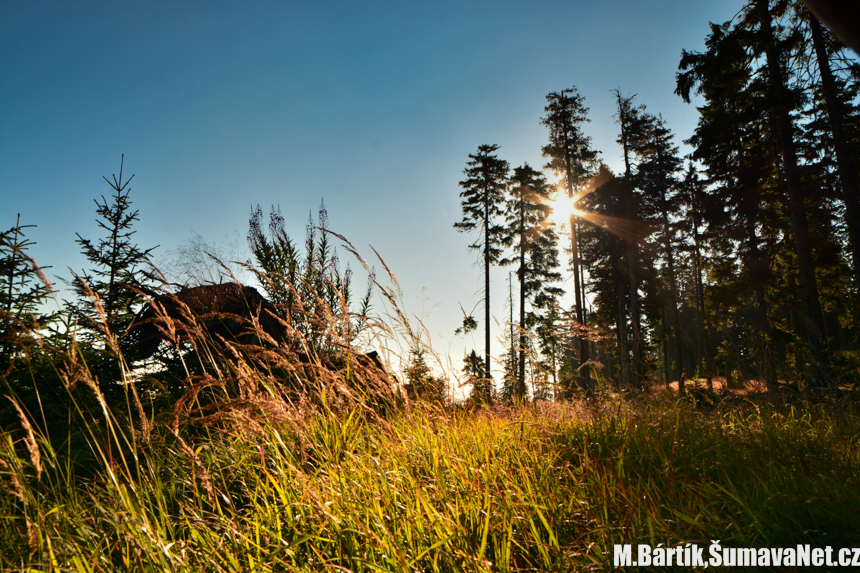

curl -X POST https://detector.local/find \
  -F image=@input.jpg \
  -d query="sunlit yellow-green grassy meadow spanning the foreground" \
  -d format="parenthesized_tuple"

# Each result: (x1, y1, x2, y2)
(0, 378, 860, 571)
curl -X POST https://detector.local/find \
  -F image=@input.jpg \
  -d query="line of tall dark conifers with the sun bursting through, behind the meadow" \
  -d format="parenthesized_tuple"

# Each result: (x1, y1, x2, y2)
(455, 0, 860, 400)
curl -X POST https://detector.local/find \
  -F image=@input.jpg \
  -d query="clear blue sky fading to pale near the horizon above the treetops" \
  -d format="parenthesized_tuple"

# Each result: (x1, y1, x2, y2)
(0, 0, 742, 384)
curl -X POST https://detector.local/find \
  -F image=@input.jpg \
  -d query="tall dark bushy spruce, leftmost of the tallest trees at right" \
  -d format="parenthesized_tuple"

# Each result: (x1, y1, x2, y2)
(675, 23, 779, 388)
